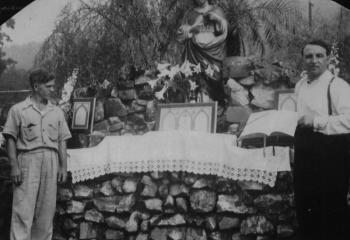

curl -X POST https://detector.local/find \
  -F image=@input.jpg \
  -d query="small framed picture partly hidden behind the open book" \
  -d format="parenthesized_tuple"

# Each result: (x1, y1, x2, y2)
(275, 89, 297, 112)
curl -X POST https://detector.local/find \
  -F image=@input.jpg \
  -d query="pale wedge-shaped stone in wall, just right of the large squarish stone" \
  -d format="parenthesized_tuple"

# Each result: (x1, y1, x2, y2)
(217, 195, 249, 214)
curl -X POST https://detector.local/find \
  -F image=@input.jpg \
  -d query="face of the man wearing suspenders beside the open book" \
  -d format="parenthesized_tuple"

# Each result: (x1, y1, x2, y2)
(303, 45, 329, 79)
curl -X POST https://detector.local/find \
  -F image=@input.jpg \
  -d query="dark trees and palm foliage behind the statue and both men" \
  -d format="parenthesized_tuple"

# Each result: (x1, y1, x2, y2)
(0, 0, 350, 89)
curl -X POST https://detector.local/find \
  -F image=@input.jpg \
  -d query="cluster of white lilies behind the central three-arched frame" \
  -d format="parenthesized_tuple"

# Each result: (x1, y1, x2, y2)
(148, 60, 219, 102)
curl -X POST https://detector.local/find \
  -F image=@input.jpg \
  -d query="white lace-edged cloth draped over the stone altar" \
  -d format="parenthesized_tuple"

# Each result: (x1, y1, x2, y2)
(67, 131, 290, 186)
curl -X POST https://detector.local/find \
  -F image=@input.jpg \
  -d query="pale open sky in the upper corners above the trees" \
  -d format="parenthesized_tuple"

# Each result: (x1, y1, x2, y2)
(0, 0, 346, 46)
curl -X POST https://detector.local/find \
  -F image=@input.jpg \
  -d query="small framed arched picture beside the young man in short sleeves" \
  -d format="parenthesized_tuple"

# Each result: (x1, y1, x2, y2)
(71, 98, 96, 133)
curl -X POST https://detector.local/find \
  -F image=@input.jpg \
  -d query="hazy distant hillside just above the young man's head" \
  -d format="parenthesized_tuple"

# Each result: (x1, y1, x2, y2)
(4, 42, 42, 70)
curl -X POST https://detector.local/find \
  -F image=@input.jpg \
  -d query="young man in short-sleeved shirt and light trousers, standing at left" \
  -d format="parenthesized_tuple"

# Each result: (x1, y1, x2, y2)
(3, 69, 71, 240)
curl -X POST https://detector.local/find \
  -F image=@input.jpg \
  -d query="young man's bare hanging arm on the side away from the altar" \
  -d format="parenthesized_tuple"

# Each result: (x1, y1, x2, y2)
(7, 136, 22, 186)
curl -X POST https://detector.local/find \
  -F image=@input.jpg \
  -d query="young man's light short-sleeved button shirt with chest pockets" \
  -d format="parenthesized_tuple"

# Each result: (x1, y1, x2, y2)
(3, 97, 71, 151)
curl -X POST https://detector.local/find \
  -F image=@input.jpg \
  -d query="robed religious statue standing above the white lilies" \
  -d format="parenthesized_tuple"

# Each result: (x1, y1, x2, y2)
(177, 0, 228, 103)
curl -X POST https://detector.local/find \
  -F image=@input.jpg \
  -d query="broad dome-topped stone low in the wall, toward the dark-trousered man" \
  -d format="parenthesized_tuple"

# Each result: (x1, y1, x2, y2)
(241, 216, 274, 235)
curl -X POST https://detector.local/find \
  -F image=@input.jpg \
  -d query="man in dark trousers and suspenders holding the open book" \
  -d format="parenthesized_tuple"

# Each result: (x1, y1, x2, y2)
(294, 40, 350, 239)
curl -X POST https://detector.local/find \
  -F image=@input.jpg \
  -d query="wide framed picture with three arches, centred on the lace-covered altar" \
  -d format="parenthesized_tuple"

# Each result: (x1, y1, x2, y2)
(156, 102, 217, 133)
